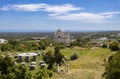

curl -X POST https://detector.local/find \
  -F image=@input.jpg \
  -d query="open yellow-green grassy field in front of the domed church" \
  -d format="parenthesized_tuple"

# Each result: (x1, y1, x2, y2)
(51, 47, 112, 79)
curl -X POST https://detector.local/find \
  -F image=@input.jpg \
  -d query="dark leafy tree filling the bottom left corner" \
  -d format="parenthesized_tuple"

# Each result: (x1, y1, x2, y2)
(0, 55, 15, 79)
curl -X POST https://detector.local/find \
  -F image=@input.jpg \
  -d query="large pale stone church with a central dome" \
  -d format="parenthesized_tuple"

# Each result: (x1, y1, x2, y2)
(54, 28, 70, 45)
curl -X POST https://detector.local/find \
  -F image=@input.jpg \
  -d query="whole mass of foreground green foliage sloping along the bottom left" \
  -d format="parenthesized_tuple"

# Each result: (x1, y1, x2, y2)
(0, 55, 53, 79)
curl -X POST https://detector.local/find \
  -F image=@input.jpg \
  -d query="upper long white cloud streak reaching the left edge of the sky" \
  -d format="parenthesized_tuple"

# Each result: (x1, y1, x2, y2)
(0, 3, 82, 14)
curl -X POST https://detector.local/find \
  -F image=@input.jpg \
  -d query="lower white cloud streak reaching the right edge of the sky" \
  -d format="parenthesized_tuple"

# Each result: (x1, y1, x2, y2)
(54, 12, 120, 23)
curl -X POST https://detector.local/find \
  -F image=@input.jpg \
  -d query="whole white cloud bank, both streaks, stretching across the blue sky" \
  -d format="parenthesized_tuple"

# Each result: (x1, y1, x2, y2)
(0, 3, 120, 22)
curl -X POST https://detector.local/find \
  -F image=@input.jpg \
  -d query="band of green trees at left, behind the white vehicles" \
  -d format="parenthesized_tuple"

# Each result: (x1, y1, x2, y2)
(0, 39, 49, 52)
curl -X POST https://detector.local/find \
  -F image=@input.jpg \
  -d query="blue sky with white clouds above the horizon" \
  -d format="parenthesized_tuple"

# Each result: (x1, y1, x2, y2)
(0, 0, 120, 32)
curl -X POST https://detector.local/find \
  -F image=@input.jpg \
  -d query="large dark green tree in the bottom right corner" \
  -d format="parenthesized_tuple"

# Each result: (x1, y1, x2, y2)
(103, 51, 120, 79)
